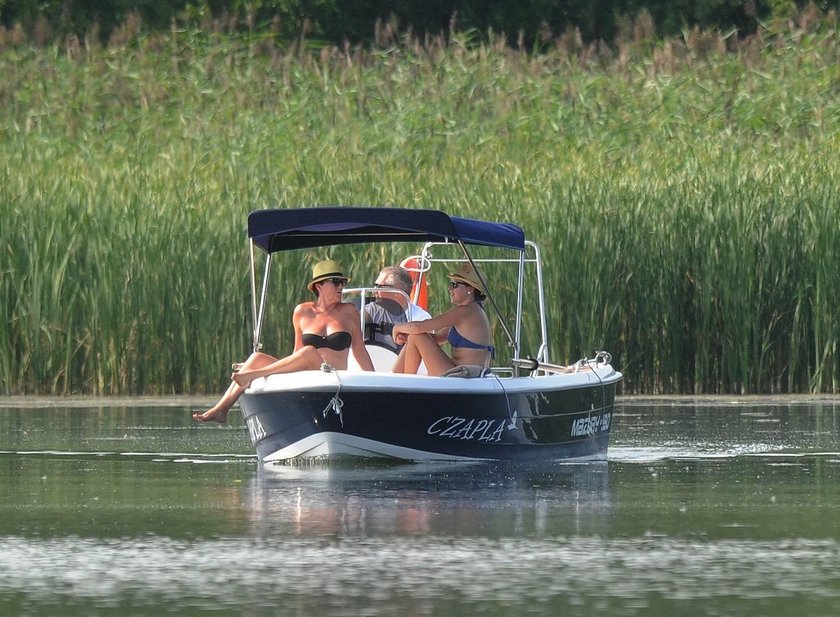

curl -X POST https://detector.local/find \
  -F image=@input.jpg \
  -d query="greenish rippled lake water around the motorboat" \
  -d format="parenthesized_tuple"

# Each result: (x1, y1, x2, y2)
(0, 398, 840, 617)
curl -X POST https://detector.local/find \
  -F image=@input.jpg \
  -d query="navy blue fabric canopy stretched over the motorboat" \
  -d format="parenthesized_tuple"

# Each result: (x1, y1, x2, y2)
(248, 206, 525, 253)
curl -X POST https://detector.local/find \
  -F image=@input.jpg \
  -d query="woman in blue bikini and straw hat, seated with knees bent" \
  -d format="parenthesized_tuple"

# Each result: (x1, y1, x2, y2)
(393, 263, 495, 375)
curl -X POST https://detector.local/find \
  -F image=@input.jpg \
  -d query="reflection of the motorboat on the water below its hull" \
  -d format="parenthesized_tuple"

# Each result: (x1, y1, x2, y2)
(243, 462, 611, 537)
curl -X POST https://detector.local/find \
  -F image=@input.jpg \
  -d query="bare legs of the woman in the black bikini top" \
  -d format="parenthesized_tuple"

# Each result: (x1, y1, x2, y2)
(193, 347, 323, 423)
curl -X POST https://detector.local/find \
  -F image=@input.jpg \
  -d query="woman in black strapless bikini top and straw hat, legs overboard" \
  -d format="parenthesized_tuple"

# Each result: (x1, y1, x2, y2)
(193, 259, 373, 422)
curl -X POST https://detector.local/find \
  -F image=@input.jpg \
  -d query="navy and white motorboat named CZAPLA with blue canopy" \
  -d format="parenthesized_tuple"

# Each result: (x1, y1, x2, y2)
(239, 206, 622, 463)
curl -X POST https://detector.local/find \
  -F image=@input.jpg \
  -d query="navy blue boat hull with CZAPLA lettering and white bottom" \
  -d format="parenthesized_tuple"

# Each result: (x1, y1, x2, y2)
(240, 380, 616, 461)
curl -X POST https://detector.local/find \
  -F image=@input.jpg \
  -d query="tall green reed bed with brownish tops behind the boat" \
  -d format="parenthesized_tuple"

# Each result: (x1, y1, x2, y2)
(0, 16, 840, 394)
